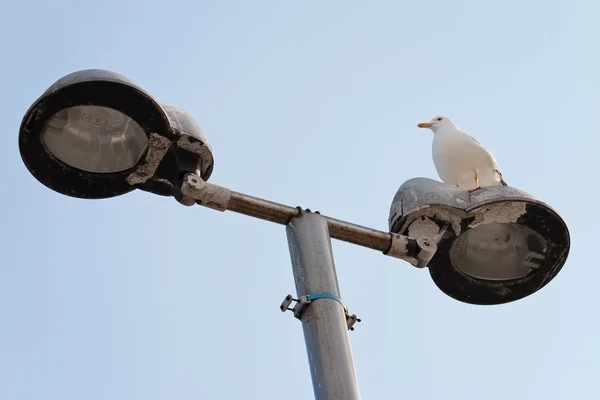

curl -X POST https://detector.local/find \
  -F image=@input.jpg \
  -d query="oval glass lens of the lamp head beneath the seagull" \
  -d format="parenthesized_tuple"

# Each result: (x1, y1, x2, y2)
(450, 222, 547, 281)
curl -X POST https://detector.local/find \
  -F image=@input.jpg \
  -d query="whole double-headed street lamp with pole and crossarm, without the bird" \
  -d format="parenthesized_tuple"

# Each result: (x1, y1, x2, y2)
(19, 70, 570, 400)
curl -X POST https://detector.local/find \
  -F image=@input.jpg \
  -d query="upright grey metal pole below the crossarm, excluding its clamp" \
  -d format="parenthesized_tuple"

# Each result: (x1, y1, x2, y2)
(286, 212, 360, 400)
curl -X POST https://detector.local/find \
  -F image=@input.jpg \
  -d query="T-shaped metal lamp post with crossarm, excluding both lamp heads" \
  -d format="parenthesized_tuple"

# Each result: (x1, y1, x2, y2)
(178, 174, 437, 400)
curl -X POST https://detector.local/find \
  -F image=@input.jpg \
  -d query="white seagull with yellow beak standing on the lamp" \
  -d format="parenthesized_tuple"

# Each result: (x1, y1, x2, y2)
(417, 117, 508, 192)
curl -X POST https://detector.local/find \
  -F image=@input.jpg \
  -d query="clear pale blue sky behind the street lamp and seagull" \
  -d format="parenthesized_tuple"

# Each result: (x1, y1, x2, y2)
(0, 0, 600, 400)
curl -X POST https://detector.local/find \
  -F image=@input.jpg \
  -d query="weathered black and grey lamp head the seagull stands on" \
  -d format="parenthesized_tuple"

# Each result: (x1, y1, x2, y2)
(389, 178, 570, 304)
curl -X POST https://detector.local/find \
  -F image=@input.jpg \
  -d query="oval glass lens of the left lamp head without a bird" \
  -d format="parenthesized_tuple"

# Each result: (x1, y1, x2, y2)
(42, 106, 148, 173)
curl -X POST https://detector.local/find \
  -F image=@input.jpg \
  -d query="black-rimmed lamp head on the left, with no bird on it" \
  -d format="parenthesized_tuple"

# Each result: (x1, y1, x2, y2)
(19, 69, 214, 199)
